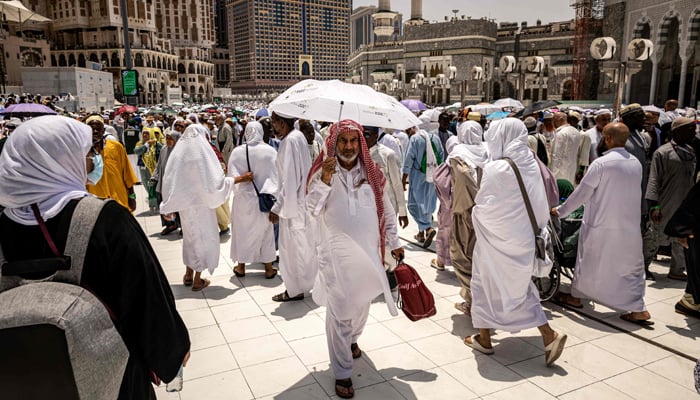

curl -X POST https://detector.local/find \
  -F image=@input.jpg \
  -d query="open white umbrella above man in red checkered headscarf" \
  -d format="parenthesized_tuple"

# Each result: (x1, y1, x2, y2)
(268, 79, 420, 129)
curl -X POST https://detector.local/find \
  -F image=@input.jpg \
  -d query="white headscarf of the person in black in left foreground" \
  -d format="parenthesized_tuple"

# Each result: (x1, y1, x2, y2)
(0, 116, 92, 225)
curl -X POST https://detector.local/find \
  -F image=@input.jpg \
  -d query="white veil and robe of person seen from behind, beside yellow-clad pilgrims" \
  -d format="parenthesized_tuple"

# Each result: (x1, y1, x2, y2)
(160, 125, 233, 273)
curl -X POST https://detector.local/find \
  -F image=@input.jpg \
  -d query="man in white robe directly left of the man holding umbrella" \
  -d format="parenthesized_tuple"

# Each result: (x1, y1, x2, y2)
(270, 113, 317, 302)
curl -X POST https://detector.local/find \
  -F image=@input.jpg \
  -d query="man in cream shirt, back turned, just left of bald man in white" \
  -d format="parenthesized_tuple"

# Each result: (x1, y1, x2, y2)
(549, 112, 590, 183)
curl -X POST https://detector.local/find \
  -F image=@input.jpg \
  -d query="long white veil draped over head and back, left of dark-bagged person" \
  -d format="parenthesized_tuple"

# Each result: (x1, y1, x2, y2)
(160, 125, 233, 214)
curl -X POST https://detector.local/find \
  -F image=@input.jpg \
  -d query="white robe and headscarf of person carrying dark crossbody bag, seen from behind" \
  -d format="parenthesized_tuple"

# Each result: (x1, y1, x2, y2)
(228, 122, 277, 264)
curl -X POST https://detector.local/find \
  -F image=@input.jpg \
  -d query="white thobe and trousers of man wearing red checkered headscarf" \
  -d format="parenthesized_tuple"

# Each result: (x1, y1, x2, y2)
(307, 162, 401, 379)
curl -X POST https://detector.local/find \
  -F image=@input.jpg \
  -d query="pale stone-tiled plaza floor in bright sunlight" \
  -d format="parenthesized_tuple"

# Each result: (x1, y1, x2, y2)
(135, 195, 700, 400)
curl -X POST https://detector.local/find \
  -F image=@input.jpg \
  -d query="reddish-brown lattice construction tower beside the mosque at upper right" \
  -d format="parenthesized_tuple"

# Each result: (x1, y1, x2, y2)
(570, 0, 605, 100)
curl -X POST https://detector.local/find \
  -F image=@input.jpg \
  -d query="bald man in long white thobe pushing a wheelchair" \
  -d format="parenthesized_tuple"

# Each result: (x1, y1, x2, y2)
(553, 123, 651, 325)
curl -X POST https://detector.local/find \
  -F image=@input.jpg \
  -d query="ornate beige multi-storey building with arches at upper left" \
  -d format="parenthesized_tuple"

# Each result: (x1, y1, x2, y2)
(17, 0, 214, 104)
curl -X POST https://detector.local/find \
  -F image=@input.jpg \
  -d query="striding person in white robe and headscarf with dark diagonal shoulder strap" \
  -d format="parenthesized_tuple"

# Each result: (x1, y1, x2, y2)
(464, 118, 566, 366)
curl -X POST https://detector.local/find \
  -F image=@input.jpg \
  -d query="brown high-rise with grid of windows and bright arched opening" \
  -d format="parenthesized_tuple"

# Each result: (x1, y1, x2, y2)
(227, 0, 352, 93)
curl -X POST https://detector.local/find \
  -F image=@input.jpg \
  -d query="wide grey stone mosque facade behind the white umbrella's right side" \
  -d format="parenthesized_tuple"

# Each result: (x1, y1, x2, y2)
(348, 1, 575, 105)
